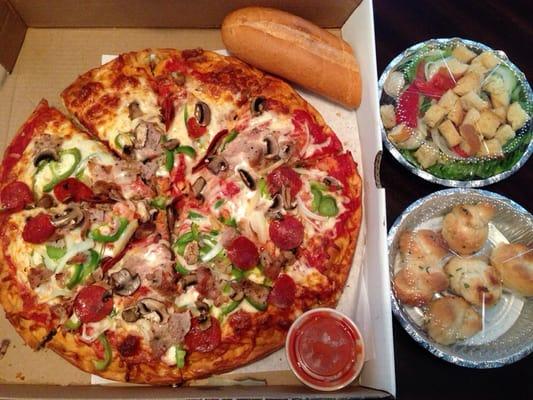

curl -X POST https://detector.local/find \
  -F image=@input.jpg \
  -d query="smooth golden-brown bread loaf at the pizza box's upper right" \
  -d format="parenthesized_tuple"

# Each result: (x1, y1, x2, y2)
(222, 7, 361, 108)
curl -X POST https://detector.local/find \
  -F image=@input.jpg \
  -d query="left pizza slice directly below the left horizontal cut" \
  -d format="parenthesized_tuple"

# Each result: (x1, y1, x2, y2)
(0, 198, 147, 348)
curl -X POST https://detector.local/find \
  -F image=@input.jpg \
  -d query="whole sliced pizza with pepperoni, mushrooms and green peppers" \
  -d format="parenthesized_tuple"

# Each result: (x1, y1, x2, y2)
(0, 49, 362, 384)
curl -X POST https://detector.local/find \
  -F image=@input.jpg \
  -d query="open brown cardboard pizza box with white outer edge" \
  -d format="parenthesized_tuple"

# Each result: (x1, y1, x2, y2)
(0, 0, 390, 399)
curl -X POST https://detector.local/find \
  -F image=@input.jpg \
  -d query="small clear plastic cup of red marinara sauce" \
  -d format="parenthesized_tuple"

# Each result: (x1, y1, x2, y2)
(285, 308, 365, 391)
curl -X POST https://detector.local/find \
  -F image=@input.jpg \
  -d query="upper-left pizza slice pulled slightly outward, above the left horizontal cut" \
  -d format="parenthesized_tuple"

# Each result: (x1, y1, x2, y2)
(0, 100, 154, 211)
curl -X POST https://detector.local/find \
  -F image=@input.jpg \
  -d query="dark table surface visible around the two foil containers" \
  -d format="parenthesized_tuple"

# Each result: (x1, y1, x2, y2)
(374, 0, 533, 400)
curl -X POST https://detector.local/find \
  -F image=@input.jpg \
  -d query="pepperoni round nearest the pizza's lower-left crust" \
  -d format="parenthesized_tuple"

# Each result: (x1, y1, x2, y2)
(74, 285, 113, 323)
